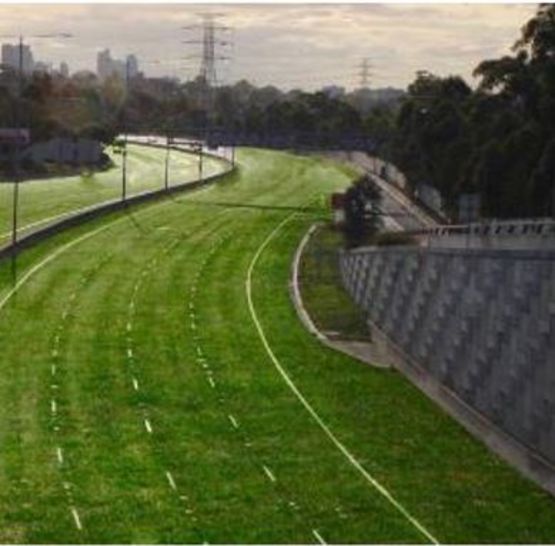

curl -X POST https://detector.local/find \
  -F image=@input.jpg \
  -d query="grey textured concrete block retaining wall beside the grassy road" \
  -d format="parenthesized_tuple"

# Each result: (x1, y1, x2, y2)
(340, 247, 555, 465)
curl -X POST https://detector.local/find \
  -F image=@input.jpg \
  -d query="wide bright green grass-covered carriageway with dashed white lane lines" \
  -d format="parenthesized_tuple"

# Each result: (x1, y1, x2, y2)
(0, 150, 555, 543)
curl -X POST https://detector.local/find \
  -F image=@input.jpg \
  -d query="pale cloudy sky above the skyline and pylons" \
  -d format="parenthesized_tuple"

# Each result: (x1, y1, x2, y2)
(0, 3, 536, 90)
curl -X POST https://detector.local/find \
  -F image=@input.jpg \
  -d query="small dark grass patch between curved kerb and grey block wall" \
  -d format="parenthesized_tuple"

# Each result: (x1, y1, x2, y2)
(299, 223, 369, 340)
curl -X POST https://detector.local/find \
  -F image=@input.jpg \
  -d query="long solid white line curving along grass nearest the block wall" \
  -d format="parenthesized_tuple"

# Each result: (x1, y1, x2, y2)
(245, 213, 439, 544)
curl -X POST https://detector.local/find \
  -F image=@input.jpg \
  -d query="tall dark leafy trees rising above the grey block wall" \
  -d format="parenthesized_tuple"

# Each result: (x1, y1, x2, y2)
(381, 4, 555, 218)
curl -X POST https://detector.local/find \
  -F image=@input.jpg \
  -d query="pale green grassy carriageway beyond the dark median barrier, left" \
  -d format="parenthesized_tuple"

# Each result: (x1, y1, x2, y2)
(0, 144, 224, 246)
